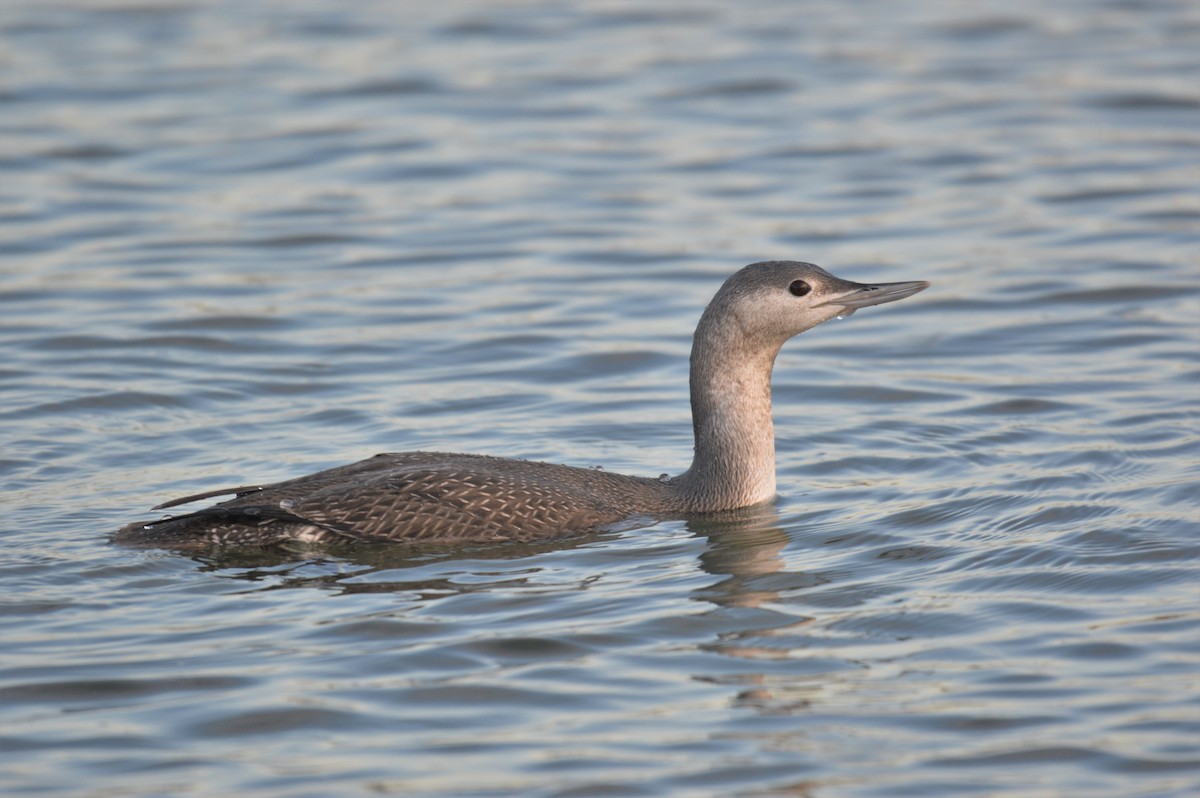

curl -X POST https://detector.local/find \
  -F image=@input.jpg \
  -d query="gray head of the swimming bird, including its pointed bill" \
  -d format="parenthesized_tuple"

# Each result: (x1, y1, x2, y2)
(702, 260, 929, 348)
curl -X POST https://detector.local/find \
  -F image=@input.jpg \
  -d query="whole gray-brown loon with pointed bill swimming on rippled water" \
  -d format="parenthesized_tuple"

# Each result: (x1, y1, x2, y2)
(113, 260, 929, 548)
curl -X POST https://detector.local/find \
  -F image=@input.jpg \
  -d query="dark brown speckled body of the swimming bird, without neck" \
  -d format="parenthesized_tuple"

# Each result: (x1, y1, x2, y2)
(119, 451, 686, 546)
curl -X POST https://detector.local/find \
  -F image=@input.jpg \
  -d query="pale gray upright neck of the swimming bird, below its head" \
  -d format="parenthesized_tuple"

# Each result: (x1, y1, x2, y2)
(677, 308, 784, 510)
